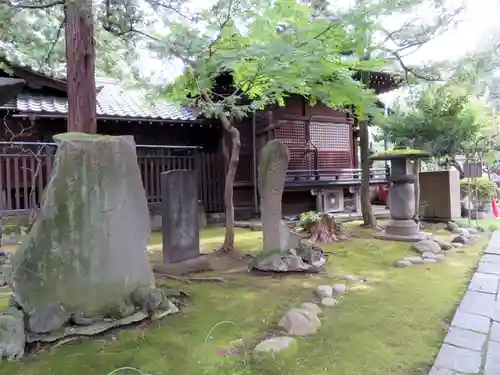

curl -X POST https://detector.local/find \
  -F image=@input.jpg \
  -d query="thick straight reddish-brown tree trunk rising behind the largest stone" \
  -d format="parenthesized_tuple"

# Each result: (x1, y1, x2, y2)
(65, 0, 97, 133)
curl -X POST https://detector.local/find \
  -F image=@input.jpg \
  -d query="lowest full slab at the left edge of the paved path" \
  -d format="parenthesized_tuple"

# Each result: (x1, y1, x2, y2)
(436, 344, 482, 374)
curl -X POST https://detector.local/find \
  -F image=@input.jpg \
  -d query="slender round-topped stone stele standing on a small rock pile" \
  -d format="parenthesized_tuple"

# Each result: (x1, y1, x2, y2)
(259, 140, 289, 251)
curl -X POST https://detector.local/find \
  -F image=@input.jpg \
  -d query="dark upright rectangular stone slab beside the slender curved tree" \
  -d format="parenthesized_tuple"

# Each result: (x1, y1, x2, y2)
(161, 170, 200, 264)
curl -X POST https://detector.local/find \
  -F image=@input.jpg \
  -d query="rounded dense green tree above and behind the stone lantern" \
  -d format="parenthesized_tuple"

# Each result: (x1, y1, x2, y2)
(379, 85, 482, 159)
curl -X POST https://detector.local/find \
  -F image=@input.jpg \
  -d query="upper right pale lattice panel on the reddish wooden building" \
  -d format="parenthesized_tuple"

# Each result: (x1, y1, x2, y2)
(311, 122, 351, 151)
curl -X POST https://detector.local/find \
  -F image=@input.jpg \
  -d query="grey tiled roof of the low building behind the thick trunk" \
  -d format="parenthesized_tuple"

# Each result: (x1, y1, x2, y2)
(1, 84, 198, 121)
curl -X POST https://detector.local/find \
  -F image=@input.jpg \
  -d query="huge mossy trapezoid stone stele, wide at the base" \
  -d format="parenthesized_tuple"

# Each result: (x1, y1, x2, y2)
(11, 133, 154, 317)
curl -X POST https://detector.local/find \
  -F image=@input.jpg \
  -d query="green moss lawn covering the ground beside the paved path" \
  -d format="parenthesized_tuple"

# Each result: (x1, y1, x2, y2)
(0, 223, 487, 375)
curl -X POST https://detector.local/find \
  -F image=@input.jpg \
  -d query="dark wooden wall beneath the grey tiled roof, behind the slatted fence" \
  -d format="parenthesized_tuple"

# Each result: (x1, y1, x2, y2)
(0, 114, 224, 212)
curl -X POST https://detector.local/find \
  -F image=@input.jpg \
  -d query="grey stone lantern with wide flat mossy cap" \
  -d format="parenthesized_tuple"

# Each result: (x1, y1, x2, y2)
(370, 150, 430, 242)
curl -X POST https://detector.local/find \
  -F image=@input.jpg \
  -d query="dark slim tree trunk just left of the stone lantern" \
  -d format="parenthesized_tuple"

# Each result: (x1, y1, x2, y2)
(359, 121, 377, 227)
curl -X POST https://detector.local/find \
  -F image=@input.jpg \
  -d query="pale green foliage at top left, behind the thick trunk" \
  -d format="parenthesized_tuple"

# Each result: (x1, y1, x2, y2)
(0, 0, 145, 79)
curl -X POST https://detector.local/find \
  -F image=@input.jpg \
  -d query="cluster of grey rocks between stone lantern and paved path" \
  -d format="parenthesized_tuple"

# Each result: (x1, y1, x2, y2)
(394, 221, 480, 268)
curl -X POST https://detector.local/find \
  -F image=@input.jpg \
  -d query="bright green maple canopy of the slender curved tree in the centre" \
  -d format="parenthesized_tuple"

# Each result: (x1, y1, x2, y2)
(154, 0, 385, 117)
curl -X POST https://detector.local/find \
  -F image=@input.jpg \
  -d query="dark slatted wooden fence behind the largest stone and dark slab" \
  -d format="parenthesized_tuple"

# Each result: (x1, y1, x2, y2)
(0, 142, 224, 215)
